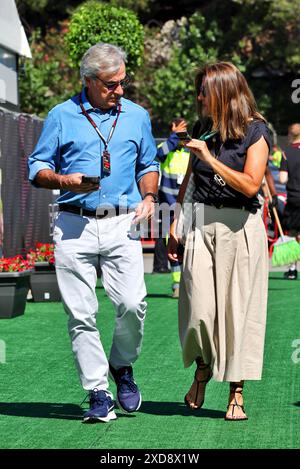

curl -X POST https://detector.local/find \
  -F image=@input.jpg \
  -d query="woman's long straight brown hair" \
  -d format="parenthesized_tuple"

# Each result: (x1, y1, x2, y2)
(195, 62, 265, 142)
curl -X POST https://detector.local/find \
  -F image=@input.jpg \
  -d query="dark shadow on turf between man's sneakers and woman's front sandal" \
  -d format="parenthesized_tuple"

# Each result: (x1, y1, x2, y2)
(139, 401, 225, 419)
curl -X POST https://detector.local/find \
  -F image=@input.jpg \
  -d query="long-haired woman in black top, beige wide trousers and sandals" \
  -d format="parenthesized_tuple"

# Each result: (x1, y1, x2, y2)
(169, 62, 270, 420)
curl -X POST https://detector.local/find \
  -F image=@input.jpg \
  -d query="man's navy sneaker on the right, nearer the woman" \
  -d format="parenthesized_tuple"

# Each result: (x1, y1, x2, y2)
(109, 365, 142, 413)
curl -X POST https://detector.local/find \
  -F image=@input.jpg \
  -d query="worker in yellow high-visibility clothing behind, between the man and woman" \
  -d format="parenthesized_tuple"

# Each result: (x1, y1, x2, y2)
(153, 117, 189, 298)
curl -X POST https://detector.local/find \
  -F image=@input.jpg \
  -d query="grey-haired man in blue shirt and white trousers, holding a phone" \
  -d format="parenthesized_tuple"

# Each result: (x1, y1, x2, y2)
(29, 43, 158, 422)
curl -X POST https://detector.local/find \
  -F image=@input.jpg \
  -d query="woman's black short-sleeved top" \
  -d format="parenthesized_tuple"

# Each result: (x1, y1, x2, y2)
(192, 120, 271, 211)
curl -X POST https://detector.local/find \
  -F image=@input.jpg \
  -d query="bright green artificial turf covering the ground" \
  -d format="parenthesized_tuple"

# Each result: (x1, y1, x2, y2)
(0, 273, 300, 449)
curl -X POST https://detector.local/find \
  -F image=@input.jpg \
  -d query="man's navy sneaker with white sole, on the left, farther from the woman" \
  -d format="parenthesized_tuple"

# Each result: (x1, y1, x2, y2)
(83, 389, 117, 422)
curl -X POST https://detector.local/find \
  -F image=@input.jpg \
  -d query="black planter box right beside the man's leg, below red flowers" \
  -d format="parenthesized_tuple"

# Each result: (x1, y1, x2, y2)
(30, 262, 61, 301)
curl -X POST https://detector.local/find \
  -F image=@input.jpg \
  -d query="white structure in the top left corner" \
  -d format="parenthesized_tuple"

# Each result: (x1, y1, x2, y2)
(0, 0, 31, 110)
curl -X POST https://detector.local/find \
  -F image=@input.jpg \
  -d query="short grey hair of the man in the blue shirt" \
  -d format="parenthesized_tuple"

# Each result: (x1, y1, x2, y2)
(80, 42, 126, 85)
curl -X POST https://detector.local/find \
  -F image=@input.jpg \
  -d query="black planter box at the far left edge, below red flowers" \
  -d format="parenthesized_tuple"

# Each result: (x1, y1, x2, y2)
(0, 270, 32, 319)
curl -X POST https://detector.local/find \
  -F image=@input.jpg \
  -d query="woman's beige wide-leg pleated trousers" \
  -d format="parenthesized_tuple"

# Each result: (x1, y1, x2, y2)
(179, 204, 268, 381)
